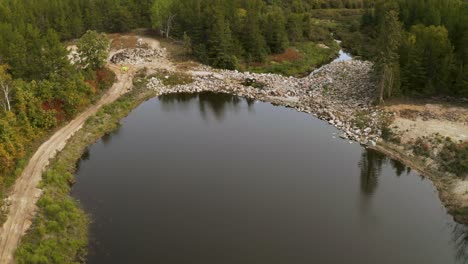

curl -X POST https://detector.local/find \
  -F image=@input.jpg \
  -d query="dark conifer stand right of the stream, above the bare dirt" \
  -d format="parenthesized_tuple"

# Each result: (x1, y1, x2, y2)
(362, 0, 468, 100)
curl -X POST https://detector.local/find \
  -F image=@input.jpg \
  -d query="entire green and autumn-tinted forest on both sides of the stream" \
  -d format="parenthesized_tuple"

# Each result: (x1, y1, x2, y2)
(0, 0, 468, 219)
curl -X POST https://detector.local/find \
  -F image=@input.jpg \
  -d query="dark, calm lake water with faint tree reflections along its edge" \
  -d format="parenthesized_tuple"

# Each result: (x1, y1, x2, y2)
(73, 93, 467, 264)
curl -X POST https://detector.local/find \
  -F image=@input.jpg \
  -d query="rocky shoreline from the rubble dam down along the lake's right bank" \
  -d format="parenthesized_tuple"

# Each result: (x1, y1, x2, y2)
(117, 40, 468, 224)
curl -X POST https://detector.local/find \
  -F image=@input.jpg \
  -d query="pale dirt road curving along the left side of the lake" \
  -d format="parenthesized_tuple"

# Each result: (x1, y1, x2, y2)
(0, 51, 136, 264)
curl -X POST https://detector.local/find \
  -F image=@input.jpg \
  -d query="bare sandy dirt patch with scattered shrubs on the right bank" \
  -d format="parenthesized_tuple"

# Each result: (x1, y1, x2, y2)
(380, 99, 468, 223)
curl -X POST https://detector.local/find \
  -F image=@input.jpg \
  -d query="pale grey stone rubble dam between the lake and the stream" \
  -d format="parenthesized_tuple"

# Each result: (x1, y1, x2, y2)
(148, 60, 386, 146)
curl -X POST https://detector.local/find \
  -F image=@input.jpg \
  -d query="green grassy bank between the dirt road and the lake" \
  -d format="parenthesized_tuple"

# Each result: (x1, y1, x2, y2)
(16, 78, 154, 264)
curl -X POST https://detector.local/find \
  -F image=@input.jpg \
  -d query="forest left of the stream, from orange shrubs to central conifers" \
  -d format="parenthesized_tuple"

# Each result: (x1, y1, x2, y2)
(0, 0, 370, 192)
